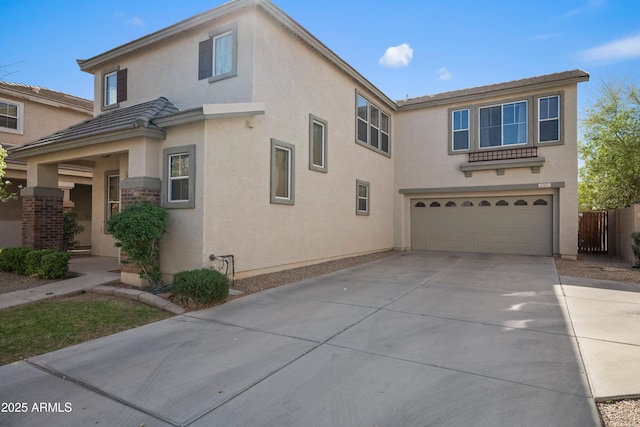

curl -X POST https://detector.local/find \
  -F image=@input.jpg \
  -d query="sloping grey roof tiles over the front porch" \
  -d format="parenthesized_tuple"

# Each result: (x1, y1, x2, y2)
(18, 97, 179, 151)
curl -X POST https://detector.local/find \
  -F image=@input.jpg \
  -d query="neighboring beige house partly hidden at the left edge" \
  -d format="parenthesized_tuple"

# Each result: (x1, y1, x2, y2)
(0, 81, 93, 248)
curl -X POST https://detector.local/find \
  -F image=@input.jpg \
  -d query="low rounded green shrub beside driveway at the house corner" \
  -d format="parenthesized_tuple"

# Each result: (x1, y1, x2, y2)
(171, 268, 229, 303)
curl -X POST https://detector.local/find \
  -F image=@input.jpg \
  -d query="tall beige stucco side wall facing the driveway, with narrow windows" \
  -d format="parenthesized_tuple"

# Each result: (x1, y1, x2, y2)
(194, 10, 394, 274)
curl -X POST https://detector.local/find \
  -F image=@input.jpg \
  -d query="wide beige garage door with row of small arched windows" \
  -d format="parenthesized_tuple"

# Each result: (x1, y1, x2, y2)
(411, 196, 553, 256)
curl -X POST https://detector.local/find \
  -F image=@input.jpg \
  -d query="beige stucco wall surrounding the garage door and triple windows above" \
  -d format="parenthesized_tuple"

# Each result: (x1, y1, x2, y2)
(394, 85, 578, 257)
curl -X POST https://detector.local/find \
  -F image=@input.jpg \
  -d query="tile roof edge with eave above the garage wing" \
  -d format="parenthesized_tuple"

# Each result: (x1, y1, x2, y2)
(396, 70, 589, 108)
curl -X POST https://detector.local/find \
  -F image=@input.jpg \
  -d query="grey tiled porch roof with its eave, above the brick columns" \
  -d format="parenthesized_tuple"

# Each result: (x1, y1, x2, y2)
(11, 97, 179, 158)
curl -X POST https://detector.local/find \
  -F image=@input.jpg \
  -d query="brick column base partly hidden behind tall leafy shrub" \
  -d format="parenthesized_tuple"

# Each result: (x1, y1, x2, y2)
(120, 177, 162, 286)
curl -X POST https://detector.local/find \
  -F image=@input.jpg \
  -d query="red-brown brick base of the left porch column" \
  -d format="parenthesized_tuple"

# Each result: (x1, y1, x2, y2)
(20, 187, 64, 250)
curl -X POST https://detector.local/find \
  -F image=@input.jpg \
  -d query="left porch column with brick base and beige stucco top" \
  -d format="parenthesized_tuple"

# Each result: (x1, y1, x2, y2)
(20, 164, 64, 249)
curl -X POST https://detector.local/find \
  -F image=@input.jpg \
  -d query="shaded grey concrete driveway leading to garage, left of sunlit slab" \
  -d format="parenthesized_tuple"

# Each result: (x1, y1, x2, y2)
(0, 252, 600, 427)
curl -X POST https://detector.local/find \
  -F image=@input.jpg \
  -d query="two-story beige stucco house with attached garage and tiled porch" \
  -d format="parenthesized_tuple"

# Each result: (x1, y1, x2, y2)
(13, 0, 588, 288)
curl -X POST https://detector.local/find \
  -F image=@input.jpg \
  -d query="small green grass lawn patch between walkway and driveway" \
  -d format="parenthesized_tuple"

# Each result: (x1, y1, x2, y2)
(0, 293, 173, 365)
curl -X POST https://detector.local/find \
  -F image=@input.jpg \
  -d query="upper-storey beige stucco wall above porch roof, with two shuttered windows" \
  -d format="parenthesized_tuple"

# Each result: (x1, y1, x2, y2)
(94, 11, 255, 114)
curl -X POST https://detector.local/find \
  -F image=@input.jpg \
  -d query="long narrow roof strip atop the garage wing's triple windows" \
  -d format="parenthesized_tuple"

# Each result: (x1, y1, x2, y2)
(397, 70, 589, 110)
